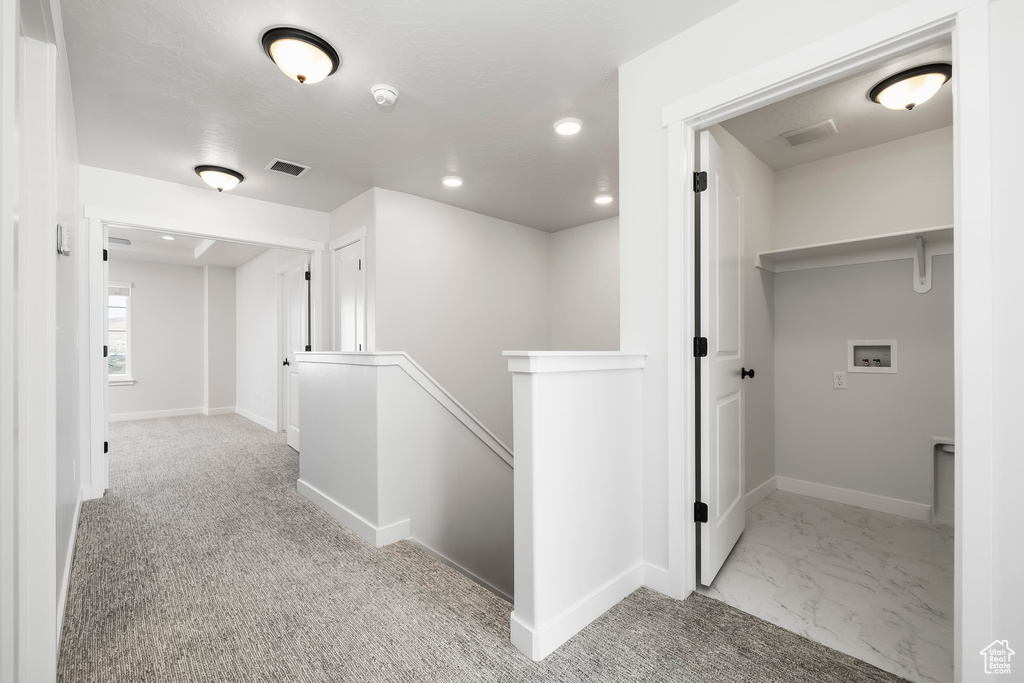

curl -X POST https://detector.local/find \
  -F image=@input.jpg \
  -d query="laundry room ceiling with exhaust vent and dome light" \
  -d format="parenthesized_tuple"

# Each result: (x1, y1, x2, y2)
(722, 40, 953, 171)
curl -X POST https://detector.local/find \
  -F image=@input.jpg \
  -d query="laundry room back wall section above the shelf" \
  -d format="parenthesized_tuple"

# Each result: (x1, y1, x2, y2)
(774, 126, 953, 249)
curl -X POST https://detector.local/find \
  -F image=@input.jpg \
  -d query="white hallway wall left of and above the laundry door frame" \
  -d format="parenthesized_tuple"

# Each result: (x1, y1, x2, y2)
(618, 0, 917, 581)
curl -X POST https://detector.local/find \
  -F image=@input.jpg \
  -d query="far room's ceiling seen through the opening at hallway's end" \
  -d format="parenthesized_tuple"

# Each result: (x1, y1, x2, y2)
(108, 225, 267, 268)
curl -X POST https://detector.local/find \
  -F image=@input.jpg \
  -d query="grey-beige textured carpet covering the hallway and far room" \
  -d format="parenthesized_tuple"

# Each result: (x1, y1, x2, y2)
(58, 416, 900, 683)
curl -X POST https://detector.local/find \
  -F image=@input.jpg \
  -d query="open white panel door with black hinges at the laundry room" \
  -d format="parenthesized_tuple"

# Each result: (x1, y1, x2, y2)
(698, 131, 745, 586)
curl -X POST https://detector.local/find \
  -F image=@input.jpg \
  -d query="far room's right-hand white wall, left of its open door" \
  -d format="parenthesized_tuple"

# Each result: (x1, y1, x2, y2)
(234, 249, 304, 430)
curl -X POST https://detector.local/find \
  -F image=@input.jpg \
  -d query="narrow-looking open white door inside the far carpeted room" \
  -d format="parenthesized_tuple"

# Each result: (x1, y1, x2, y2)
(281, 261, 309, 451)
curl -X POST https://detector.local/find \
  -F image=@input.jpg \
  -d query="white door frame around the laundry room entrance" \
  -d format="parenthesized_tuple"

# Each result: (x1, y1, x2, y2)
(663, 0, 994, 680)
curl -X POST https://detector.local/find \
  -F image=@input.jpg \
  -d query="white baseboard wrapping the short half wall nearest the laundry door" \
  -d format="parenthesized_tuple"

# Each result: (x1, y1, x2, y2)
(510, 562, 644, 661)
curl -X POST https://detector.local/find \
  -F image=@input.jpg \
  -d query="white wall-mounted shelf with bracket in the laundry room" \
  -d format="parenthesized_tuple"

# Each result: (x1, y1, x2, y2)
(756, 225, 953, 274)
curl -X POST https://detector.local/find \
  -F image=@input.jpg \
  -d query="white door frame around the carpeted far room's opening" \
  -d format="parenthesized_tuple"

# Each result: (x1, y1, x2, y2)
(82, 206, 330, 501)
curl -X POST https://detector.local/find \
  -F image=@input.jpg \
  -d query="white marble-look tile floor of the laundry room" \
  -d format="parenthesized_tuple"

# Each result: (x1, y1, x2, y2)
(698, 492, 953, 683)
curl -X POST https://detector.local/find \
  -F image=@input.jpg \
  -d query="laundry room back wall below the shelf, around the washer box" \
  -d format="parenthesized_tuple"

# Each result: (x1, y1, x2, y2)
(775, 256, 959, 507)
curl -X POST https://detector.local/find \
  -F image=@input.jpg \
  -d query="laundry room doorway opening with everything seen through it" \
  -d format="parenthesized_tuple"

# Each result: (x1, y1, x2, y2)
(693, 40, 955, 681)
